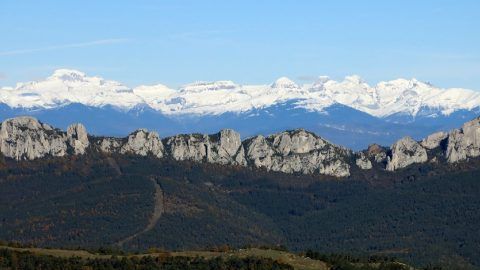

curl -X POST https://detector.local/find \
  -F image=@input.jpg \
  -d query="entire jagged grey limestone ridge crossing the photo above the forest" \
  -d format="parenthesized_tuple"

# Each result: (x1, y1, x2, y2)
(0, 116, 480, 177)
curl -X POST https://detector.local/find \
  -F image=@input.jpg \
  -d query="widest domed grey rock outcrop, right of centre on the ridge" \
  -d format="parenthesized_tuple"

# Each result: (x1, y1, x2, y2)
(244, 129, 351, 177)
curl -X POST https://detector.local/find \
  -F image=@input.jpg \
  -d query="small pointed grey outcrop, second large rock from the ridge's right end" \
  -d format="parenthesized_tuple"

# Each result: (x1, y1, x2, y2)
(386, 136, 428, 171)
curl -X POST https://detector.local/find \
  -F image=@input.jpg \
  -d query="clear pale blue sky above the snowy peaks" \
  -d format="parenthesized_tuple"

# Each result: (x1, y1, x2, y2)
(0, 0, 480, 90)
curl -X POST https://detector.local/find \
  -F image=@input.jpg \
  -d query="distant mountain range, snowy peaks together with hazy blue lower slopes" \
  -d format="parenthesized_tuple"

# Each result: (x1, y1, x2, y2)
(0, 69, 480, 149)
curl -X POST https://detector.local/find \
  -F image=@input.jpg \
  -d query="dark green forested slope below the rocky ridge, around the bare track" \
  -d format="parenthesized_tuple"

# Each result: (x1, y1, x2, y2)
(0, 153, 480, 269)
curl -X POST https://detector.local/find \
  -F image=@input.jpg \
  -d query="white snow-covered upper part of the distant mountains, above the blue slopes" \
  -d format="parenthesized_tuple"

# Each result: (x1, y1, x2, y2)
(0, 69, 480, 117)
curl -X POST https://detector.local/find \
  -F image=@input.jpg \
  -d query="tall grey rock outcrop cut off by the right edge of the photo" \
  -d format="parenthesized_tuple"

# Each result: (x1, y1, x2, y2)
(446, 117, 480, 163)
